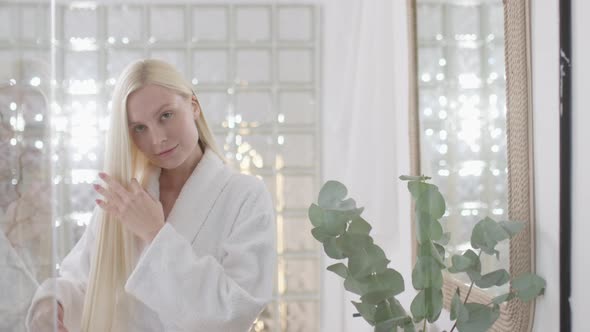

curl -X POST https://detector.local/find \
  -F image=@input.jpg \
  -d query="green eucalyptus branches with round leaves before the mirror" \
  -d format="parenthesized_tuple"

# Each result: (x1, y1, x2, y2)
(308, 175, 545, 332)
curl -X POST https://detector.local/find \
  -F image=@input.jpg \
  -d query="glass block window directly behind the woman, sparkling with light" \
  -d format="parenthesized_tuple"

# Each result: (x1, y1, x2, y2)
(0, 1, 320, 331)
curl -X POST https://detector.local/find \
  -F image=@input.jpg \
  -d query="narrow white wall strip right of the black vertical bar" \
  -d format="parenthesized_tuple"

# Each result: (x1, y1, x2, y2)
(570, 0, 590, 332)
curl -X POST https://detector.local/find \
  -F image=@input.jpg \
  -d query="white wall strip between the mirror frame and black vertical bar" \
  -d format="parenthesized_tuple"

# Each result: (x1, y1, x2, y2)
(532, 0, 559, 331)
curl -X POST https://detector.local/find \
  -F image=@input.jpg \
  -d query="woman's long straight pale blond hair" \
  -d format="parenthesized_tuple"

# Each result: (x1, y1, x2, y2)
(81, 59, 225, 332)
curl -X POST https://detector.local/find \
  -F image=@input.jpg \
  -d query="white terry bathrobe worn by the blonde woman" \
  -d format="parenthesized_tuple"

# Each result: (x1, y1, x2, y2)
(27, 150, 276, 332)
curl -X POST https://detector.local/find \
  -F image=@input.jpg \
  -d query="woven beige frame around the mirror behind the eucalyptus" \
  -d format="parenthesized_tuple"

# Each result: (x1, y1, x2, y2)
(407, 0, 535, 331)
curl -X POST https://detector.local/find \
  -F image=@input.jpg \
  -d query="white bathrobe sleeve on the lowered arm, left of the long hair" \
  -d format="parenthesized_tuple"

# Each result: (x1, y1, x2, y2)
(25, 208, 99, 331)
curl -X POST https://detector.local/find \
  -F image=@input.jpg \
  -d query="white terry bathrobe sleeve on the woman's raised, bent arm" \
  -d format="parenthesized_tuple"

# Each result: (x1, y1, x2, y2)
(125, 179, 276, 332)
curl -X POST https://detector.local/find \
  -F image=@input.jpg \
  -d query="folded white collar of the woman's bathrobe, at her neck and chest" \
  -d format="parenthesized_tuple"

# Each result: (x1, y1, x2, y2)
(147, 149, 233, 243)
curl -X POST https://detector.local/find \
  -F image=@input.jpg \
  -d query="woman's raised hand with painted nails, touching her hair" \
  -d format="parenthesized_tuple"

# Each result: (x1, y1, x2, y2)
(94, 173, 165, 243)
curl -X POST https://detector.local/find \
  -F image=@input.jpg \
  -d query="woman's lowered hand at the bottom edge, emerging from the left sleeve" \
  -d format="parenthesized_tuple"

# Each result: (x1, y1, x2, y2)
(29, 298, 68, 332)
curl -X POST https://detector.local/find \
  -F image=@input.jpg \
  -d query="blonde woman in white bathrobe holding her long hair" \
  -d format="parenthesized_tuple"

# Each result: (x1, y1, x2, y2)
(26, 60, 276, 332)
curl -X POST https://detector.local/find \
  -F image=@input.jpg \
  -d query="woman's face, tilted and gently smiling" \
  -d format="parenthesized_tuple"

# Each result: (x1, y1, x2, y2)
(127, 84, 202, 169)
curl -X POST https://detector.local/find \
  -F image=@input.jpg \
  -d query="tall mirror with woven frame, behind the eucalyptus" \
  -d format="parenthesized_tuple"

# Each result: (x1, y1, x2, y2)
(409, 0, 534, 331)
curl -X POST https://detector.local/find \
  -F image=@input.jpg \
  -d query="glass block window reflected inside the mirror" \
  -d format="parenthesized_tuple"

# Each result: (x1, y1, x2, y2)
(417, 0, 509, 293)
